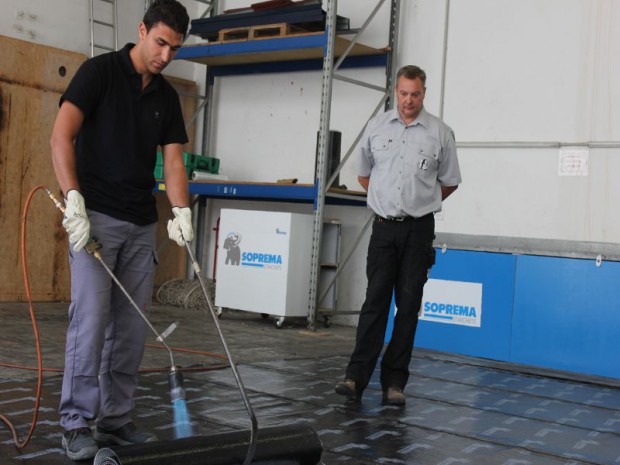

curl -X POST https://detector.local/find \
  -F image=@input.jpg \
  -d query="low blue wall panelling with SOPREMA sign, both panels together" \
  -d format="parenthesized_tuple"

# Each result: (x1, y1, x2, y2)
(385, 250, 620, 379)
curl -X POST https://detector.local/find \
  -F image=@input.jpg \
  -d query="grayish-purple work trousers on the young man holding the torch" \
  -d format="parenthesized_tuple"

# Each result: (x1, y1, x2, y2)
(60, 210, 157, 431)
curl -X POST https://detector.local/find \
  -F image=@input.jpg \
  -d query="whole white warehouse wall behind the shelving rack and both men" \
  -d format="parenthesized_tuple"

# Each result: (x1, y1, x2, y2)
(0, 0, 620, 340)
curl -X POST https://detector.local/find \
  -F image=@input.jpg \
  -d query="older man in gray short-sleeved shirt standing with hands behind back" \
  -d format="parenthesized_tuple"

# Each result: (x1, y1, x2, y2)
(336, 66, 461, 405)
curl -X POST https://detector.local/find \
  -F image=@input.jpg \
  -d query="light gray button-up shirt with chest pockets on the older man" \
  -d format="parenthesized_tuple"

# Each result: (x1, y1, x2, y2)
(358, 108, 461, 218)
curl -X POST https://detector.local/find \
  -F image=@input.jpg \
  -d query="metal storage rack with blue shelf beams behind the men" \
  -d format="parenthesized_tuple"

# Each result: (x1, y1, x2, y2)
(172, 0, 400, 329)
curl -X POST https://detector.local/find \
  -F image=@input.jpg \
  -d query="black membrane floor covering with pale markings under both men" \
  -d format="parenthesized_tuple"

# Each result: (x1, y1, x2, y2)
(0, 356, 620, 465)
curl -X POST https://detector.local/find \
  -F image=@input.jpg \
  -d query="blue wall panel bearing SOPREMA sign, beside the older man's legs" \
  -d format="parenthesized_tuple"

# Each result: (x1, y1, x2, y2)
(386, 249, 516, 360)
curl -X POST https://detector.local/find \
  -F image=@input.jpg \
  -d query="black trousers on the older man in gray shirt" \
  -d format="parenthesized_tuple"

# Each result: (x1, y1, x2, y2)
(346, 214, 435, 392)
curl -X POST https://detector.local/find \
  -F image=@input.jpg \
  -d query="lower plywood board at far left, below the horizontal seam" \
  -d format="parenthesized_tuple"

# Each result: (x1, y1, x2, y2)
(0, 84, 68, 300)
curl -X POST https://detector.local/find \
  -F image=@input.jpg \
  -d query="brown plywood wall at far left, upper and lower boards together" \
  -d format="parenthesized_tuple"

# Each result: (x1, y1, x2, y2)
(0, 36, 86, 301)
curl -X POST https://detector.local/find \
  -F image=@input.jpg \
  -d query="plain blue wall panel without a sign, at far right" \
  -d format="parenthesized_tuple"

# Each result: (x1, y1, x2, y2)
(511, 256, 620, 378)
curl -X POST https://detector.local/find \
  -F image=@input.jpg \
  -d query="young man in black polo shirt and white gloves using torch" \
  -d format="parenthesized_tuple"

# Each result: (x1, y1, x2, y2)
(51, 0, 193, 460)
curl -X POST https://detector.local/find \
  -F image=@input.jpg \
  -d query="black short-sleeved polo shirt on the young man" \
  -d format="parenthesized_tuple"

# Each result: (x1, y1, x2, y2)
(60, 44, 188, 225)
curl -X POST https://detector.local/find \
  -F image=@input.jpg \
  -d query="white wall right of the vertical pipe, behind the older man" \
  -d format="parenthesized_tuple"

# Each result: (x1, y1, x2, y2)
(432, 0, 620, 239)
